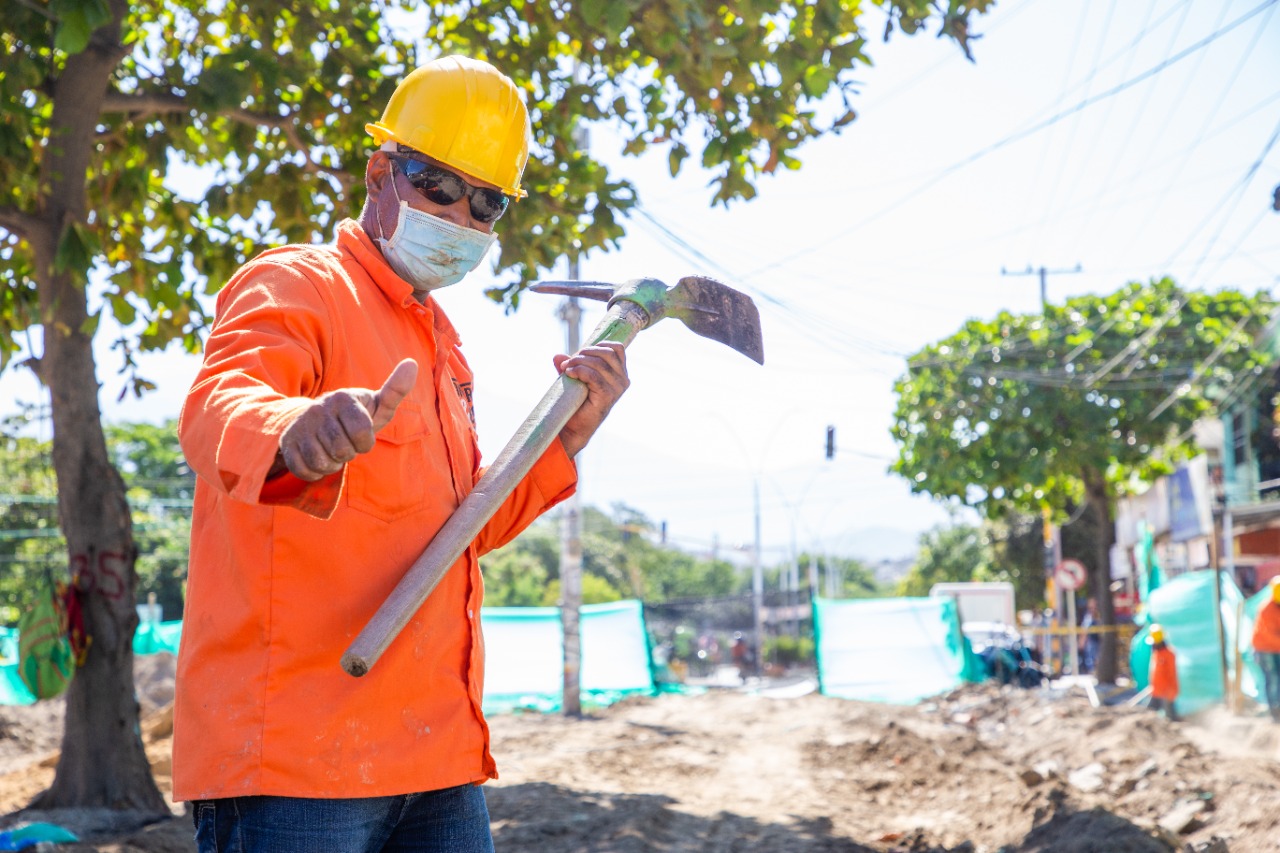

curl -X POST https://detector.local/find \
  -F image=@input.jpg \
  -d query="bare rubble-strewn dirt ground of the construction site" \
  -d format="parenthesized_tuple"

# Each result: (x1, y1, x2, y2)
(0, 656, 1280, 853)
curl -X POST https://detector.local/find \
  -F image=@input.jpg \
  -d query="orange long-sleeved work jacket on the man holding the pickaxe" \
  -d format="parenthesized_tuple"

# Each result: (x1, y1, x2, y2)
(173, 220, 576, 799)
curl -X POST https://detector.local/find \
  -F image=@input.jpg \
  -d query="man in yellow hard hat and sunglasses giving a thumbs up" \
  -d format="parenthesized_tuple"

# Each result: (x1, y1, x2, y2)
(174, 56, 628, 853)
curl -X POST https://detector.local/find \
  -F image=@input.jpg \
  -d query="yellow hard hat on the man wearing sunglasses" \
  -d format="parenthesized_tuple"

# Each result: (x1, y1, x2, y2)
(365, 56, 530, 199)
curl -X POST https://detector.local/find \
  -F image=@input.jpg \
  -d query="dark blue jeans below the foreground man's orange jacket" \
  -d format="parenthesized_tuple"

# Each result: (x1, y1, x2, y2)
(192, 785, 493, 853)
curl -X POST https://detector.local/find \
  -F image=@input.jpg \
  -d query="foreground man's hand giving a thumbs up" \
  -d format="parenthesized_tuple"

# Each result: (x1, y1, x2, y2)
(268, 359, 417, 483)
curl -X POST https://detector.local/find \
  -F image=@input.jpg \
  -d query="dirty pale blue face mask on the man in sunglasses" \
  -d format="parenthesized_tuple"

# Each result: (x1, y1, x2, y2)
(378, 183, 498, 292)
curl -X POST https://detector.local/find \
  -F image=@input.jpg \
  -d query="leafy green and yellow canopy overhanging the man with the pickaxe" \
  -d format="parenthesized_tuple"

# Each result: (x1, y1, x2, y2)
(0, 0, 991, 376)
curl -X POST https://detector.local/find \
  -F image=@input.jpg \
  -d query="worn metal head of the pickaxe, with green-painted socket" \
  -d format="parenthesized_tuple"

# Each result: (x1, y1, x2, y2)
(529, 275, 764, 364)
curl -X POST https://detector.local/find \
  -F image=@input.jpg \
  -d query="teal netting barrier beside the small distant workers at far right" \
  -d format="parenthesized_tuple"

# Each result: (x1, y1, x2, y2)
(1129, 571, 1262, 713)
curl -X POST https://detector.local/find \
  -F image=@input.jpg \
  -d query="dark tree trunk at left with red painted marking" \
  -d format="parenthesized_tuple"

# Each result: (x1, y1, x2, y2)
(32, 0, 168, 813)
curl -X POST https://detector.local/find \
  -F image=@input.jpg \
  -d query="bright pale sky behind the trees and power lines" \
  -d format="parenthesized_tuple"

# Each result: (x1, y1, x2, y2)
(0, 0, 1280, 562)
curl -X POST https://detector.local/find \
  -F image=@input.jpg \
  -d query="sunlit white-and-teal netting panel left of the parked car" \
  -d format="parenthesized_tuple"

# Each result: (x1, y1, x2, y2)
(813, 598, 962, 704)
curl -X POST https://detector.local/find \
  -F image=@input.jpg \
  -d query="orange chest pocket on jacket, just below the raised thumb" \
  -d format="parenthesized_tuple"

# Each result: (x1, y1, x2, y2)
(347, 401, 428, 521)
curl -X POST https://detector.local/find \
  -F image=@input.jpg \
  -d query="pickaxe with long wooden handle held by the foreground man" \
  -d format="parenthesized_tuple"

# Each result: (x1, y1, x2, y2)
(342, 275, 764, 676)
